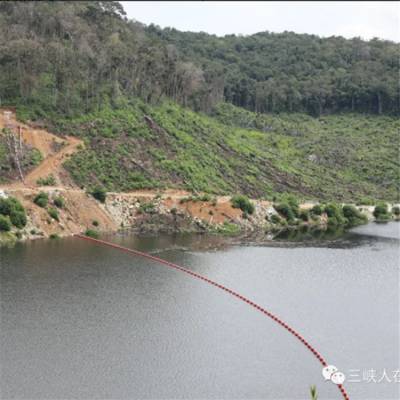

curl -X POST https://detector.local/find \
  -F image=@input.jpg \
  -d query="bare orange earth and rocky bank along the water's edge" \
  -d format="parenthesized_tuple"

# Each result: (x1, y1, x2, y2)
(0, 186, 394, 245)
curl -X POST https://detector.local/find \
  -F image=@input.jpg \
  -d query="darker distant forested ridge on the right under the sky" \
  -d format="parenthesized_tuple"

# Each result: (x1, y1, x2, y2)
(147, 25, 400, 115)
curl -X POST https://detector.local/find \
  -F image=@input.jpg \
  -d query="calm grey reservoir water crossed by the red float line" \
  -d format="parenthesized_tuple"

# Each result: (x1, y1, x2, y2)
(0, 223, 400, 400)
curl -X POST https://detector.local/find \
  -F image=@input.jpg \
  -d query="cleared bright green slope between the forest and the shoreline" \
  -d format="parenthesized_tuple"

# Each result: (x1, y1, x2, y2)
(24, 100, 400, 202)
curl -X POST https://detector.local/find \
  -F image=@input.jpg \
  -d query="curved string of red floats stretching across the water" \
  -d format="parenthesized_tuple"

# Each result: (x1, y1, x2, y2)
(75, 234, 350, 400)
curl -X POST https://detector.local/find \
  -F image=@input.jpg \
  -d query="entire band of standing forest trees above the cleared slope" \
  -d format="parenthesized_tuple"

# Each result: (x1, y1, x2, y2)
(0, 1, 399, 115)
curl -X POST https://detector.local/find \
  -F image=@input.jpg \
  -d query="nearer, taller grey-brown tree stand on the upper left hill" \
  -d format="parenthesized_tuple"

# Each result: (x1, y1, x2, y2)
(0, 1, 206, 115)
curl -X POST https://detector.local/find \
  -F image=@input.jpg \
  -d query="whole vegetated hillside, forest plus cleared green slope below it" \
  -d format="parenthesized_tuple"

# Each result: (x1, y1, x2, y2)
(0, 1, 400, 202)
